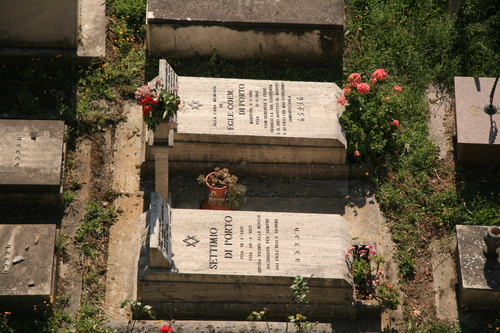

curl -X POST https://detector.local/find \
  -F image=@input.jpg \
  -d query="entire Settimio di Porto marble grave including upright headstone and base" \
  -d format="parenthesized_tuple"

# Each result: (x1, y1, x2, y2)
(138, 193, 356, 320)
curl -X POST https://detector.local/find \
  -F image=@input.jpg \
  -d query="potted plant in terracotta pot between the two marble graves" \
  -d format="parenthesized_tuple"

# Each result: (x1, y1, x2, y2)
(198, 167, 247, 209)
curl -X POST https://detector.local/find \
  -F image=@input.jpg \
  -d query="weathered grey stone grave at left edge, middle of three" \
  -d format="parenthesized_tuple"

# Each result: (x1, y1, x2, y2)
(0, 119, 65, 206)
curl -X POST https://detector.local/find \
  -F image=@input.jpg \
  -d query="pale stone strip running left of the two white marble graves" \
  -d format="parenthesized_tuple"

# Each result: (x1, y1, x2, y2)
(104, 102, 145, 321)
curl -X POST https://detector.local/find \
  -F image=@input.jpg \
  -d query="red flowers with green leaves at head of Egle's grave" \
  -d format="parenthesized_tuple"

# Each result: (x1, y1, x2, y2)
(134, 82, 181, 132)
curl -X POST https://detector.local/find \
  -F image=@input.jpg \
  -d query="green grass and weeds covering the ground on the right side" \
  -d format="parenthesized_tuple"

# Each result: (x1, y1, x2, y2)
(344, 0, 500, 332)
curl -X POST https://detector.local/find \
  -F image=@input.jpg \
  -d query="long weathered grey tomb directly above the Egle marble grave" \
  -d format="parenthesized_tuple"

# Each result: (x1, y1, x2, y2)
(146, 0, 344, 65)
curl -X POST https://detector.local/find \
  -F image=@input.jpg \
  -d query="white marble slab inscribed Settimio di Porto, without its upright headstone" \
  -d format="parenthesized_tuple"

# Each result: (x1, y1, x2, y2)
(138, 193, 353, 304)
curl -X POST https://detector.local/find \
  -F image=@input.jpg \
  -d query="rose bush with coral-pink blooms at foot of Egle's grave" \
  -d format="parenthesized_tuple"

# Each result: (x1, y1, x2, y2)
(337, 68, 403, 161)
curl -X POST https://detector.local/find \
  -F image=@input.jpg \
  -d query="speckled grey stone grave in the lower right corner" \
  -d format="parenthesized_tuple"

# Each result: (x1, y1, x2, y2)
(457, 225, 500, 308)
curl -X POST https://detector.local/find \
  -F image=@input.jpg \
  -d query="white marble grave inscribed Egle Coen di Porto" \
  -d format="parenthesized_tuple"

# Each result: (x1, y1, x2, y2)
(148, 60, 349, 179)
